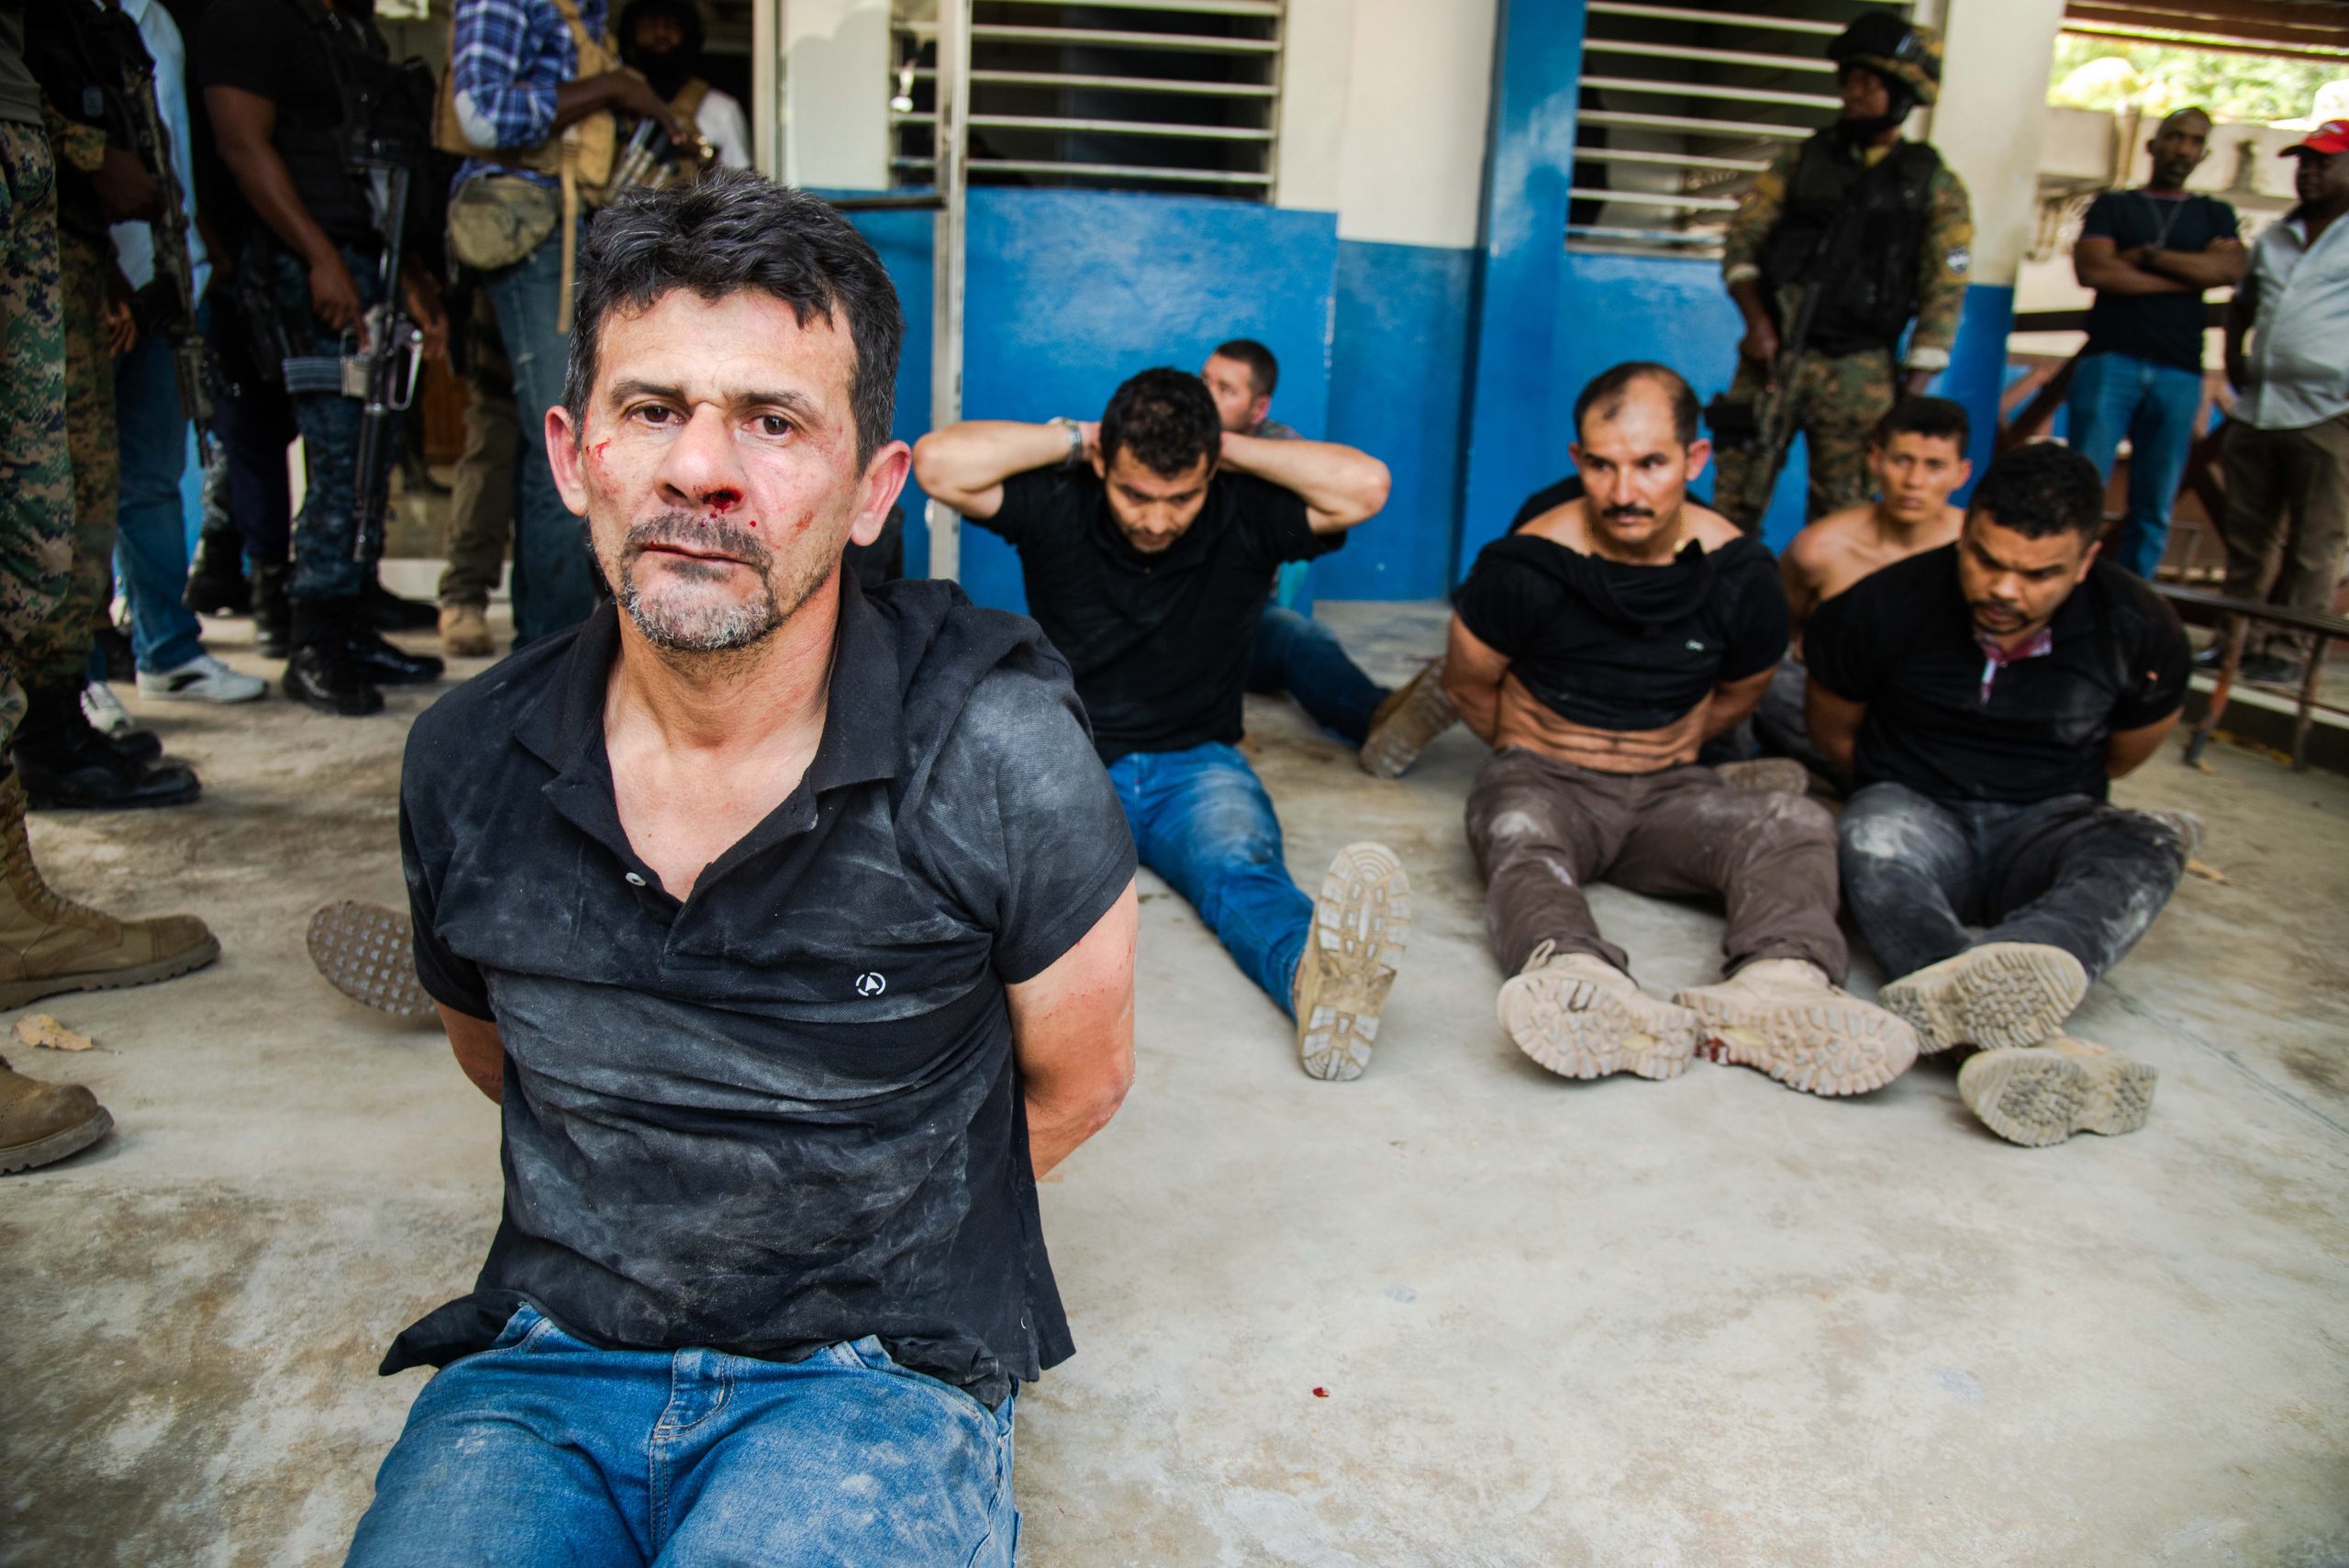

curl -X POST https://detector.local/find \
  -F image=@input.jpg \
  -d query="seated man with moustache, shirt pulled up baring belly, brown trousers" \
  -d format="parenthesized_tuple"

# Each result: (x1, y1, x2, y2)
(1444, 361, 1917, 1094)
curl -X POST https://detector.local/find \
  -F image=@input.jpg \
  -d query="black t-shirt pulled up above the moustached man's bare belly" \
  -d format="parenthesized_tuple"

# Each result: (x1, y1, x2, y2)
(1452, 533, 1787, 732)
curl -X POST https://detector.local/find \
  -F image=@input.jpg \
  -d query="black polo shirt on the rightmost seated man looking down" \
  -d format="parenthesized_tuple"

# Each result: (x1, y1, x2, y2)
(1802, 545, 2189, 803)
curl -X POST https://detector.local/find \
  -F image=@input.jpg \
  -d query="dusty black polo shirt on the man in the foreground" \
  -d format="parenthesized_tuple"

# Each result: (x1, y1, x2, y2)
(383, 573, 1134, 1406)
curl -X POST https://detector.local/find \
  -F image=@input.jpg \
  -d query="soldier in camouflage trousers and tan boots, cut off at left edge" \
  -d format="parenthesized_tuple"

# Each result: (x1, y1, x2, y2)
(0, 0, 221, 1172)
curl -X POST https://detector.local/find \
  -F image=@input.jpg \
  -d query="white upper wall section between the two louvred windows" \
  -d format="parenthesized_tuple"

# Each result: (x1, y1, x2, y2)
(1274, 0, 1498, 247)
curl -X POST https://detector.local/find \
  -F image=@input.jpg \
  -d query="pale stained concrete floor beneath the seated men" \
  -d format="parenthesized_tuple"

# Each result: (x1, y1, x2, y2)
(0, 586, 2349, 1568)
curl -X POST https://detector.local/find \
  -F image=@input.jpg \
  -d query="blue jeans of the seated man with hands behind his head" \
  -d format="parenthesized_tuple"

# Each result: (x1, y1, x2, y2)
(1108, 741, 1313, 1012)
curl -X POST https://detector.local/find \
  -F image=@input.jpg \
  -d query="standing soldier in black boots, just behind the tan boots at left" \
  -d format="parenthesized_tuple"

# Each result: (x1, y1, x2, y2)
(14, 0, 197, 807)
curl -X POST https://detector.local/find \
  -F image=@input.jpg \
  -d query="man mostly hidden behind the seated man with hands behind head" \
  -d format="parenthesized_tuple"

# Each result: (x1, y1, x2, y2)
(1198, 338, 1454, 777)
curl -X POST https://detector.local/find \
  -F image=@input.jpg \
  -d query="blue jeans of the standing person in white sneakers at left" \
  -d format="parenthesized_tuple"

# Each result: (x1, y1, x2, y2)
(115, 336, 205, 673)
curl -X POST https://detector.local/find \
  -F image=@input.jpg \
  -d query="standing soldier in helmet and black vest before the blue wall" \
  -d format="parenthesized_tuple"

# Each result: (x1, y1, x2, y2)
(1715, 12, 1973, 528)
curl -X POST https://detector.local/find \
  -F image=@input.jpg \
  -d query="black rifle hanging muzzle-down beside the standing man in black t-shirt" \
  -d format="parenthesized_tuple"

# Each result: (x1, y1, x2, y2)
(284, 143, 425, 559)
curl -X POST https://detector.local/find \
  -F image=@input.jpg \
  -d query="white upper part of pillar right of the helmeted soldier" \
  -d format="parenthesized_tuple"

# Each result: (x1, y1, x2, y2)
(1929, 0, 2063, 286)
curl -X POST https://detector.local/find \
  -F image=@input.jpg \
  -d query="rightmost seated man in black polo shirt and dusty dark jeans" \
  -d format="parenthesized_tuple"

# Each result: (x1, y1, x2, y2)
(1804, 434, 2187, 1143)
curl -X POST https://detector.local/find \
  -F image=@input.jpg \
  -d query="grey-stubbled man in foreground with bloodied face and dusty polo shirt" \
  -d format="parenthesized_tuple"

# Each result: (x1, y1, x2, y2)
(350, 169, 1134, 1568)
